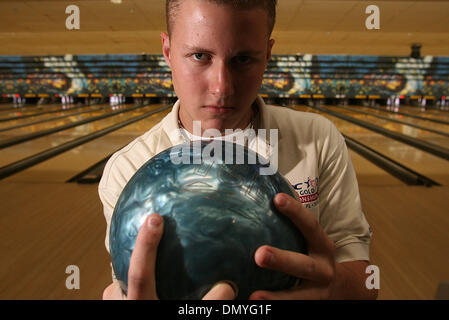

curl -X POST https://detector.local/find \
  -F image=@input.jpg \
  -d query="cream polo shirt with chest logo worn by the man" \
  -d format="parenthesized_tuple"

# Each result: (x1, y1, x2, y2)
(98, 97, 371, 268)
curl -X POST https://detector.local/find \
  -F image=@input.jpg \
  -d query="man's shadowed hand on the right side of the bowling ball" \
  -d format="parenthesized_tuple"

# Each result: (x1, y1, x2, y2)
(250, 194, 337, 300)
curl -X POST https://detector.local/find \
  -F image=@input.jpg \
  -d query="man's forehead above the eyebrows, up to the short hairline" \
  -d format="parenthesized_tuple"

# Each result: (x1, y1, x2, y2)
(171, 0, 268, 43)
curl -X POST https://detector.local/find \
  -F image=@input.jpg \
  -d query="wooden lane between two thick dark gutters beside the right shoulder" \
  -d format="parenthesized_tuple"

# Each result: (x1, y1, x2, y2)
(294, 106, 449, 185)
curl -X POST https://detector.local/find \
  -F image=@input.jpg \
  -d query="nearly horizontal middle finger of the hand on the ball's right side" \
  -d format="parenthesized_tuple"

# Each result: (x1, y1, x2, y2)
(254, 246, 334, 283)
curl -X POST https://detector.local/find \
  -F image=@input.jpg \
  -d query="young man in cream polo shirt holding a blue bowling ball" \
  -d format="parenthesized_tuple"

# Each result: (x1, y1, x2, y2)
(99, 0, 377, 299)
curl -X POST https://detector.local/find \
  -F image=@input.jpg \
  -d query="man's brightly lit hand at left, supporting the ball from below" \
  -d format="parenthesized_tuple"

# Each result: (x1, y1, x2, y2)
(103, 214, 235, 300)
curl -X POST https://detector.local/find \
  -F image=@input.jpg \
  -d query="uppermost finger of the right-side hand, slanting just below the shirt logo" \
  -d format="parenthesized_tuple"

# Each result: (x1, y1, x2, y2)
(274, 193, 333, 252)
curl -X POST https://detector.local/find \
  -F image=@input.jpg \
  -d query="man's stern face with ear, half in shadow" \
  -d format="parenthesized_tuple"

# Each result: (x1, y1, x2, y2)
(162, 0, 274, 132)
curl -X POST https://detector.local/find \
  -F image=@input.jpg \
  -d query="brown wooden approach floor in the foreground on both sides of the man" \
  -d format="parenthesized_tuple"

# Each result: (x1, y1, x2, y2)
(0, 182, 449, 299)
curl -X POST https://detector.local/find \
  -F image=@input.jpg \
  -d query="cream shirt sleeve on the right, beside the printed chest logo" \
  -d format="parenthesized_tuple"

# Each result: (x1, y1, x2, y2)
(319, 121, 372, 262)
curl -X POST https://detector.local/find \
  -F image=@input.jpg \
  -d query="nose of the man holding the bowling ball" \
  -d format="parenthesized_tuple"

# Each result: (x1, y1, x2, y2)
(209, 61, 234, 98)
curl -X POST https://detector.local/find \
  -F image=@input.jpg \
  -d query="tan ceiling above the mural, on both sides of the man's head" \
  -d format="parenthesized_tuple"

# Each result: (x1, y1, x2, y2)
(0, 0, 449, 56)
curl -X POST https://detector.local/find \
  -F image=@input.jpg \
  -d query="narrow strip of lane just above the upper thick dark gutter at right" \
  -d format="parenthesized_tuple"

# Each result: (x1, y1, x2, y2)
(323, 106, 449, 148)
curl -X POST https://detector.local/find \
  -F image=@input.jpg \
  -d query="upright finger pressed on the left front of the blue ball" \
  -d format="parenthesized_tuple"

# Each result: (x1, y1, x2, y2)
(128, 214, 164, 299)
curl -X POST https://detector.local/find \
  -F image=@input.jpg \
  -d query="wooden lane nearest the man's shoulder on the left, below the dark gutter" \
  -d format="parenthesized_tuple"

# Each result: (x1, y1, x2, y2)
(4, 105, 171, 182)
